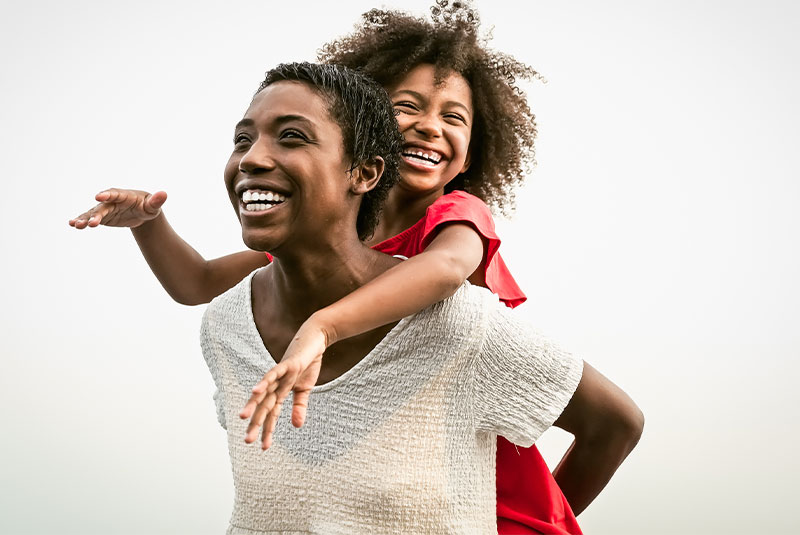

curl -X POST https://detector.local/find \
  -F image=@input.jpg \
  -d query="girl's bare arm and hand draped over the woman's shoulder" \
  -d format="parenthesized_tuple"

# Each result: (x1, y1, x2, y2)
(239, 223, 485, 449)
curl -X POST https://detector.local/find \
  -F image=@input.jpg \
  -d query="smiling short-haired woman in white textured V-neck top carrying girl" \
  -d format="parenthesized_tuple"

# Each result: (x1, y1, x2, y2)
(201, 64, 641, 534)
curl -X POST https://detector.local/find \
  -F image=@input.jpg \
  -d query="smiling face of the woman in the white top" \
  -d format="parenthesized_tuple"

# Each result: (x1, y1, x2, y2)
(225, 81, 358, 251)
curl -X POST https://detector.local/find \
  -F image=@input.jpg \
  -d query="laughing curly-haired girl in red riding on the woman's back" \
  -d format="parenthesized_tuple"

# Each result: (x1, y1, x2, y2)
(70, 1, 636, 533)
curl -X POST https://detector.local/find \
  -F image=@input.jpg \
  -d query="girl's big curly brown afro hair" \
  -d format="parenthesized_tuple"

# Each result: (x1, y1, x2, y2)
(319, 0, 541, 214)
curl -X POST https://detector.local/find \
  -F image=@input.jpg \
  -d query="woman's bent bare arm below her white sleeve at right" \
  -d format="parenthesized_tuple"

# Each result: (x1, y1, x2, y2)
(553, 363, 644, 515)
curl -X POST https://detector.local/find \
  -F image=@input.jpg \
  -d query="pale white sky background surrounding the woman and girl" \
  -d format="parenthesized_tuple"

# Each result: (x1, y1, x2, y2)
(0, 0, 800, 534)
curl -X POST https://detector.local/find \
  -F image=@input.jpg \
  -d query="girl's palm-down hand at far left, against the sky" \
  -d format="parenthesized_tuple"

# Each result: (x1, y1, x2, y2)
(69, 188, 167, 229)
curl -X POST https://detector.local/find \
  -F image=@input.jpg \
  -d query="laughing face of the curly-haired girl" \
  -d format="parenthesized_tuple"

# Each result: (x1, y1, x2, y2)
(387, 63, 473, 195)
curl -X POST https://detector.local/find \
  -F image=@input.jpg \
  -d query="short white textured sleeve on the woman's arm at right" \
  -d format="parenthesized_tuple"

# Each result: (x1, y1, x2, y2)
(473, 303, 583, 447)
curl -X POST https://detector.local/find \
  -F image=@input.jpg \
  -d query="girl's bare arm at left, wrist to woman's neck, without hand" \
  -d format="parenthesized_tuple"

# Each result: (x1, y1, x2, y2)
(131, 212, 267, 305)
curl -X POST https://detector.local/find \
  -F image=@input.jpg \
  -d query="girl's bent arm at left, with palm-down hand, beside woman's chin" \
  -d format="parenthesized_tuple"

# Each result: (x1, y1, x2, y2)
(69, 188, 268, 305)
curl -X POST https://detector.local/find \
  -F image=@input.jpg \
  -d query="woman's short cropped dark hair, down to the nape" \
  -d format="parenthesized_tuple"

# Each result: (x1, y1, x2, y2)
(256, 62, 403, 240)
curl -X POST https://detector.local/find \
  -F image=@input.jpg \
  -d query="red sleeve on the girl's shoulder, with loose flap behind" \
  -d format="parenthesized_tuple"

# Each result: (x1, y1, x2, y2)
(420, 191, 527, 308)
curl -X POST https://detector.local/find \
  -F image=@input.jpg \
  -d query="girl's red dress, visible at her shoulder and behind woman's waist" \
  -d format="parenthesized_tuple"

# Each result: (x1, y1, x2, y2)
(267, 191, 582, 535)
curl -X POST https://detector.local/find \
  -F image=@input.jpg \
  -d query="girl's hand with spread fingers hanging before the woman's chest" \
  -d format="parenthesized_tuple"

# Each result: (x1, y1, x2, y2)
(239, 316, 332, 450)
